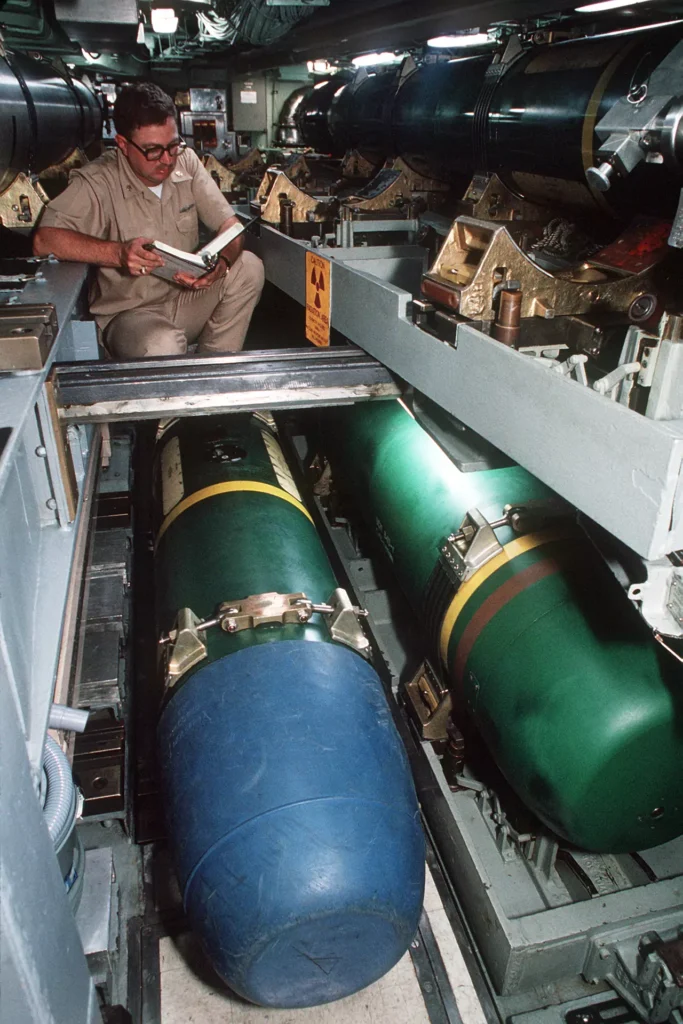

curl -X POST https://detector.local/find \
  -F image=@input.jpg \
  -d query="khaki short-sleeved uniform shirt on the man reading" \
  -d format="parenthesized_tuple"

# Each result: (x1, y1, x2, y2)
(40, 150, 234, 328)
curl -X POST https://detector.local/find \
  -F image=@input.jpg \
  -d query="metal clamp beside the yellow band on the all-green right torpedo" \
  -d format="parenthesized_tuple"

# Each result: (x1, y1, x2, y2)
(439, 498, 571, 586)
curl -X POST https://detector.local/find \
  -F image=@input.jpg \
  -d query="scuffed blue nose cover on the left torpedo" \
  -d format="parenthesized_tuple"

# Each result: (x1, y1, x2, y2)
(159, 640, 424, 1008)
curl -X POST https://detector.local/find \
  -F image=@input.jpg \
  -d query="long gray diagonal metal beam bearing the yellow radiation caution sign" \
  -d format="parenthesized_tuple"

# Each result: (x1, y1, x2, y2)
(250, 225, 683, 559)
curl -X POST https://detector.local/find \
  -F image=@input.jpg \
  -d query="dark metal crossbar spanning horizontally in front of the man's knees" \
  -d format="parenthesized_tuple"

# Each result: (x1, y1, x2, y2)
(54, 345, 400, 423)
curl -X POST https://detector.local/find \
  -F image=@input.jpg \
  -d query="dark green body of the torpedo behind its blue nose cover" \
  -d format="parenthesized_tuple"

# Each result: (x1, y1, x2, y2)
(155, 416, 337, 679)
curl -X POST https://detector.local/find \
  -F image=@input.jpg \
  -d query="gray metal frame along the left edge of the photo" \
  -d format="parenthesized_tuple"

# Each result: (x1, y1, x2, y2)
(0, 264, 101, 1024)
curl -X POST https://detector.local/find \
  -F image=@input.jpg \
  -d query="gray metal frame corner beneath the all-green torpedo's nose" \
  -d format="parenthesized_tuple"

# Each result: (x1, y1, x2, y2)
(423, 743, 683, 996)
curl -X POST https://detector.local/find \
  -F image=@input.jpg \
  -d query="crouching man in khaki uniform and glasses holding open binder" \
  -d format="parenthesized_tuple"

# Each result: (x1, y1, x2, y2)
(34, 83, 263, 359)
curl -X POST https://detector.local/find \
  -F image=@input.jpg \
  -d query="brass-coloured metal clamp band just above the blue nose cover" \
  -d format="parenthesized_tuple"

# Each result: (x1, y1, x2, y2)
(159, 588, 370, 688)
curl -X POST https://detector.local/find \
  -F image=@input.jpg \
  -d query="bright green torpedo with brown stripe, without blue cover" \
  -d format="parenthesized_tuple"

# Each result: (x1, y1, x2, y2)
(330, 402, 683, 852)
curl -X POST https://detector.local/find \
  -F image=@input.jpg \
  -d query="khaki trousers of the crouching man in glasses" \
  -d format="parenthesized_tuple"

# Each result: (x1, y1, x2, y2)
(102, 252, 263, 359)
